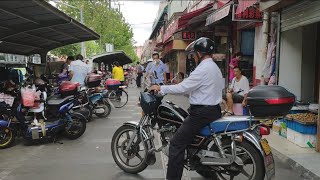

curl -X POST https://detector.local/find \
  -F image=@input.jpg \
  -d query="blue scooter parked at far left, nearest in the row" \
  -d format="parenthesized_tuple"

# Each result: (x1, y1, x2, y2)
(0, 89, 86, 148)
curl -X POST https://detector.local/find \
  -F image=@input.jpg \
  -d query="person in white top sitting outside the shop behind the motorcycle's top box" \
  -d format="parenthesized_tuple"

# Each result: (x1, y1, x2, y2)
(223, 67, 250, 116)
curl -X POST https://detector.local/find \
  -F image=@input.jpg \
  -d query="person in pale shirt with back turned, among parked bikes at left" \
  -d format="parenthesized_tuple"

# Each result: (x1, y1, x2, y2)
(69, 54, 91, 86)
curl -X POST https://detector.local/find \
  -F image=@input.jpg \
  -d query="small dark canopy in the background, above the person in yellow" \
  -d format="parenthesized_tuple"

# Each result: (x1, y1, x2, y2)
(92, 51, 132, 65)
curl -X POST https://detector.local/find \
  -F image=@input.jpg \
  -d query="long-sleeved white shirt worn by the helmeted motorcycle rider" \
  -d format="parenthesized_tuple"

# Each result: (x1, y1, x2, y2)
(161, 58, 224, 105)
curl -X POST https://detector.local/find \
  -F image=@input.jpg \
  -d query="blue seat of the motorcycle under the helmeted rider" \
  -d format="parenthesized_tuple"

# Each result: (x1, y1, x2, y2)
(199, 116, 250, 137)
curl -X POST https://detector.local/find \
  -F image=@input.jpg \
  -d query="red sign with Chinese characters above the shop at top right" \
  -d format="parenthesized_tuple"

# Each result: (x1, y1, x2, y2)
(232, 4, 263, 22)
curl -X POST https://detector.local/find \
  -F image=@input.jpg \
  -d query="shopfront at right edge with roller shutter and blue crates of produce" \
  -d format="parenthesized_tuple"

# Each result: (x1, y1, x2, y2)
(263, 0, 320, 151)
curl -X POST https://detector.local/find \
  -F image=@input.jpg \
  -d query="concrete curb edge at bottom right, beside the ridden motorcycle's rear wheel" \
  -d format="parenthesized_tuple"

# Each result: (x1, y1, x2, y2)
(272, 148, 320, 180)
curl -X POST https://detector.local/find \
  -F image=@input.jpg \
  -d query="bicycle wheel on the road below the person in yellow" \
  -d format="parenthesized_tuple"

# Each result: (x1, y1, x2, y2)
(108, 89, 129, 108)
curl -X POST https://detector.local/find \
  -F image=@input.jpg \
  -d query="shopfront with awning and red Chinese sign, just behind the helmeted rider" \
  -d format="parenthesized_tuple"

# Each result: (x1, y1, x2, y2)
(206, 1, 262, 84)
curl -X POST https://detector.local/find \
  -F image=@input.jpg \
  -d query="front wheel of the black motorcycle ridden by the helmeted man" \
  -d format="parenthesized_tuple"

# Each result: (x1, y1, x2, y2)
(111, 125, 148, 174)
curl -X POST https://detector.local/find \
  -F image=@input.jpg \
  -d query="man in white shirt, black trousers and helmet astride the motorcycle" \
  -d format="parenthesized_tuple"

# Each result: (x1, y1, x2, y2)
(149, 37, 224, 180)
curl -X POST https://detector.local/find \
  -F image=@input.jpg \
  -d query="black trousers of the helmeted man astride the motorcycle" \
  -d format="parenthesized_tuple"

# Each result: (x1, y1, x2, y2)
(167, 105, 221, 180)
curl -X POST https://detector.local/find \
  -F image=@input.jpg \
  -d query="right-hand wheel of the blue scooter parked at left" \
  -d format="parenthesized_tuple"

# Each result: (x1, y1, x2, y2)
(64, 112, 87, 140)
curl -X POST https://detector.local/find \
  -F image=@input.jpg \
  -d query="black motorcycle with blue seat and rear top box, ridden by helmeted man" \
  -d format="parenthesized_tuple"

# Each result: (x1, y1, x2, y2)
(111, 87, 295, 180)
